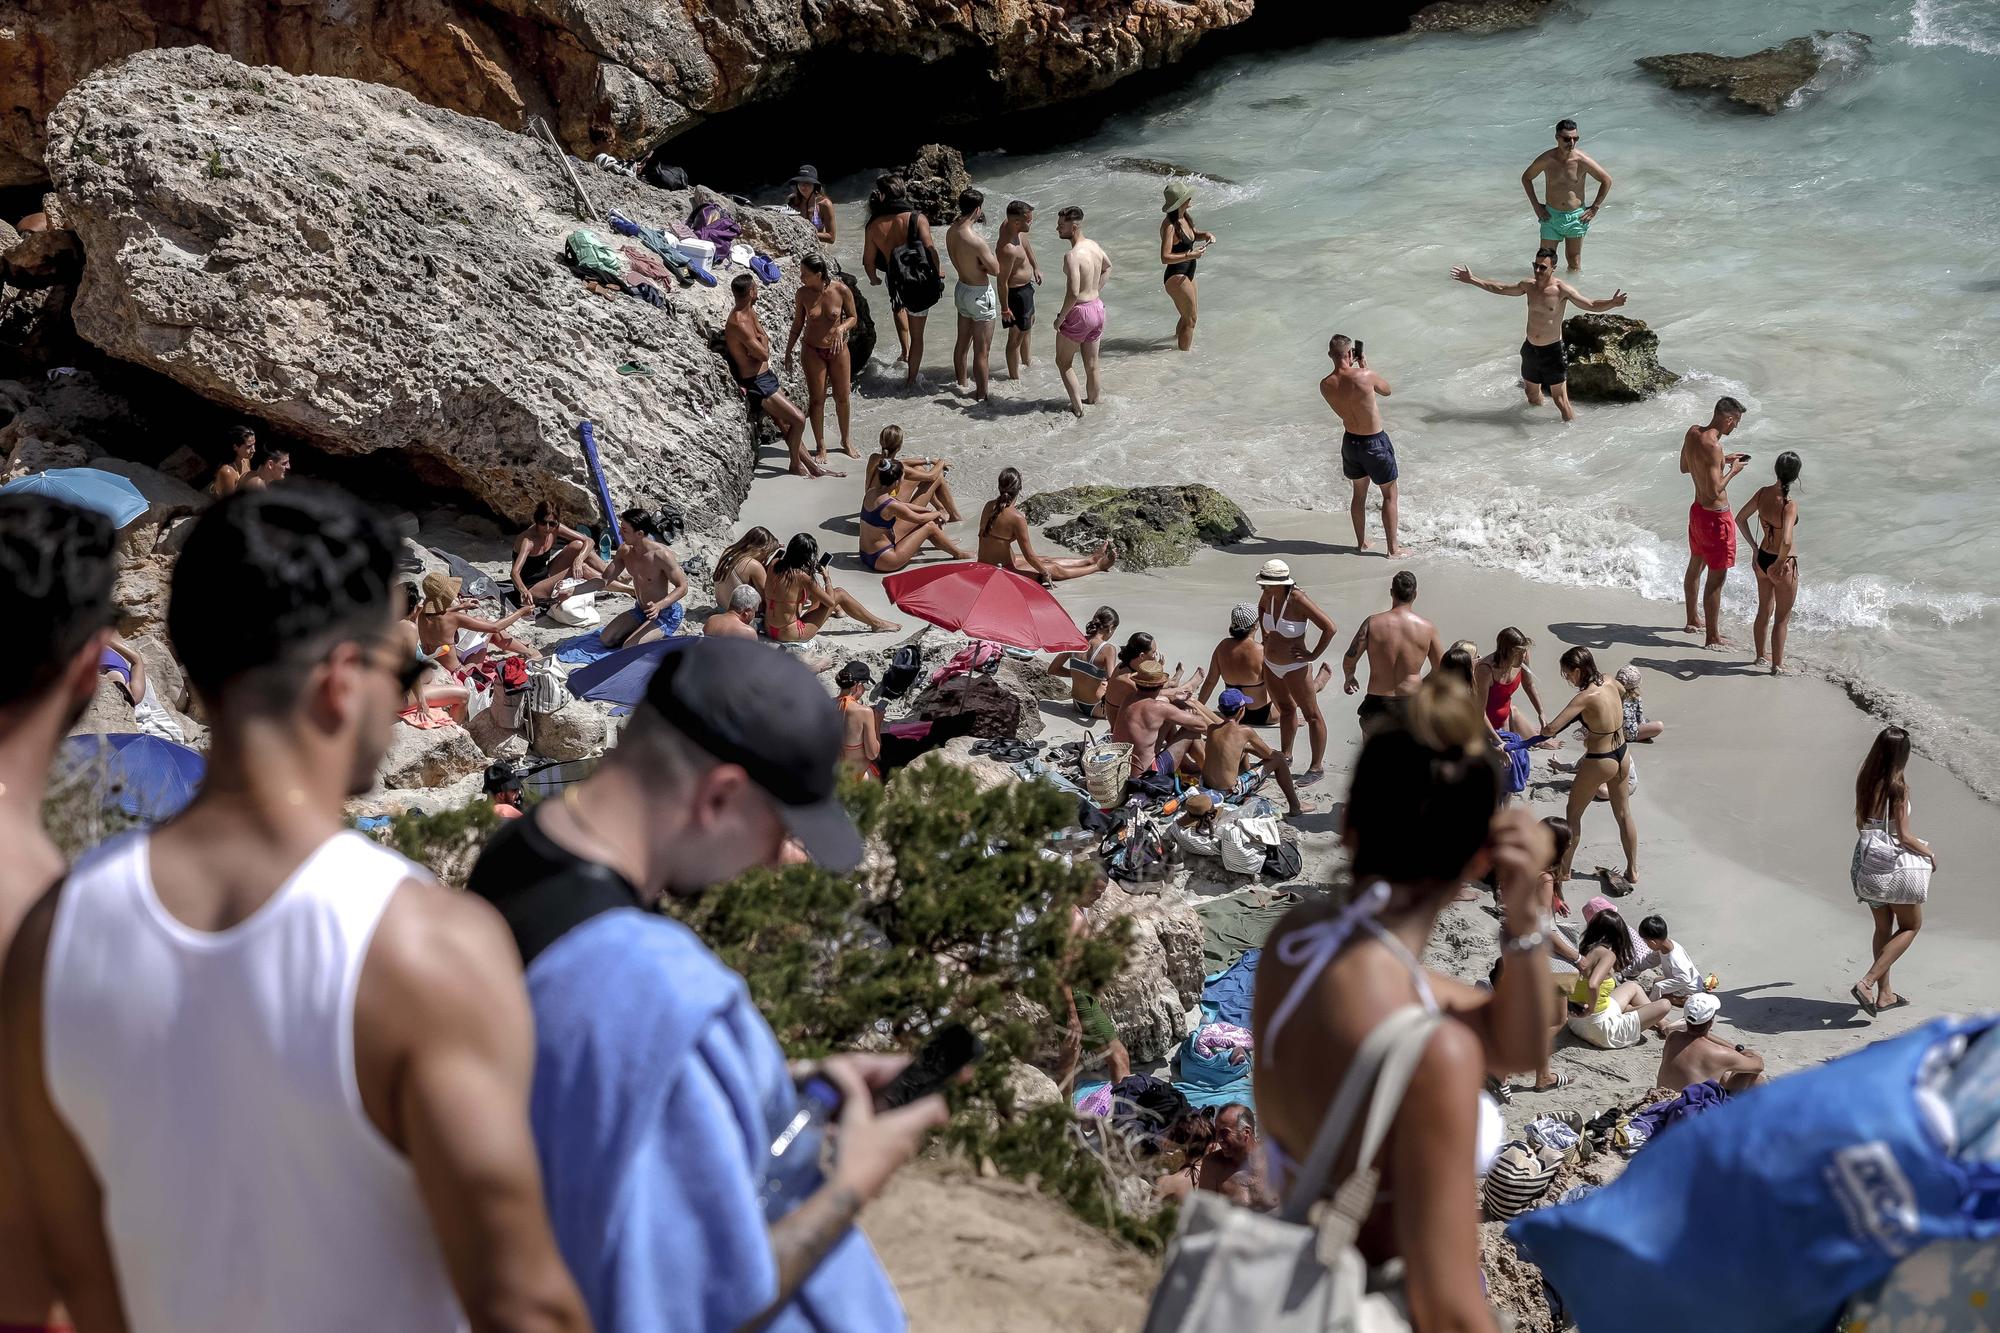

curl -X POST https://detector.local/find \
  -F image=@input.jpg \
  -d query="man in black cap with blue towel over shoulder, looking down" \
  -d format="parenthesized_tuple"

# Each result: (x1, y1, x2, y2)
(468, 638, 946, 1333)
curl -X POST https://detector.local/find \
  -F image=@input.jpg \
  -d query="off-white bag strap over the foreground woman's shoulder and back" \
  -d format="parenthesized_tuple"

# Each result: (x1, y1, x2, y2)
(1278, 1005, 1442, 1216)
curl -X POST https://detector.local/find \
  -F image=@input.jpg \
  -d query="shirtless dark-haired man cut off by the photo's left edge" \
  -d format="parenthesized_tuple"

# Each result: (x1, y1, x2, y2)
(0, 494, 118, 1329)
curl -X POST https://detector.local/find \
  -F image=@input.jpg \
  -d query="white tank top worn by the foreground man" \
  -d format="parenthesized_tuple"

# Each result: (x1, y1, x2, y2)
(42, 833, 464, 1333)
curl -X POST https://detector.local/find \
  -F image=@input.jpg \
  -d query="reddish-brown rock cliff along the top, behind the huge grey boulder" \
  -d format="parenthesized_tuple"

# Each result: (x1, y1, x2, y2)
(0, 0, 1254, 186)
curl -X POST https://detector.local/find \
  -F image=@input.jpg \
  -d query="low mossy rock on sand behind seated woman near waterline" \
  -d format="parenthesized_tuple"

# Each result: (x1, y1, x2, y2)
(1022, 484, 1256, 570)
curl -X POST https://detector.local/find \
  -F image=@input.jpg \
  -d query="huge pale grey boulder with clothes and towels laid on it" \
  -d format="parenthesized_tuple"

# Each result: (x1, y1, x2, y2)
(48, 48, 816, 528)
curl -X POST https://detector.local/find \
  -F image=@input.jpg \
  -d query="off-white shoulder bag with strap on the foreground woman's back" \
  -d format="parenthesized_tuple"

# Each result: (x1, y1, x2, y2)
(1144, 1005, 1442, 1333)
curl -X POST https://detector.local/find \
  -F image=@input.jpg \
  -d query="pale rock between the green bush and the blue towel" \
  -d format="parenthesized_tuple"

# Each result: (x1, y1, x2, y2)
(1088, 885, 1202, 1063)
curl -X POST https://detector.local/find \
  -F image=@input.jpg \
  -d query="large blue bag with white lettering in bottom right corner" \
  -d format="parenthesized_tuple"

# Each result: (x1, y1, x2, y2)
(1508, 1015, 2000, 1333)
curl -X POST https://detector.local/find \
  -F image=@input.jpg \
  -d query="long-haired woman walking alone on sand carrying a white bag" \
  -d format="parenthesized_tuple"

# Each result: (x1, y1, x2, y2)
(1848, 727, 1938, 1019)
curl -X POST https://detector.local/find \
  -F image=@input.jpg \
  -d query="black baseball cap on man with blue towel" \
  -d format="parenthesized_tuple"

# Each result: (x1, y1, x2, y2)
(646, 638, 862, 873)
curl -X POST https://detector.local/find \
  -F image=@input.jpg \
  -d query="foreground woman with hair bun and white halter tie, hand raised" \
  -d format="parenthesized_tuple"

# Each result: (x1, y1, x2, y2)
(1252, 675, 1558, 1329)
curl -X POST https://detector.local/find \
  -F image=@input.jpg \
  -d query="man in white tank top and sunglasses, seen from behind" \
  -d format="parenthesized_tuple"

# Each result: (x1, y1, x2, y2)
(0, 482, 588, 1333)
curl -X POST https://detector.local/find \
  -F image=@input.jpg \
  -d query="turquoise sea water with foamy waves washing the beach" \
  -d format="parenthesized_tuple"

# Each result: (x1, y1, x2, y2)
(838, 0, 2000, 791)
